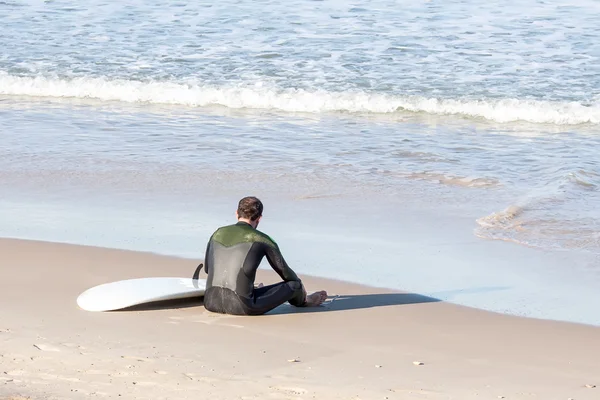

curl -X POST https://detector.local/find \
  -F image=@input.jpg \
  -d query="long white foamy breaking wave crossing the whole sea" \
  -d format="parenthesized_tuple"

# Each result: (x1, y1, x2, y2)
(0, 73, 600, 125)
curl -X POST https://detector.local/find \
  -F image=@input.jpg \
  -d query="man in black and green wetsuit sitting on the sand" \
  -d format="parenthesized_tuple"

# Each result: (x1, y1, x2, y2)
(204, 197, 327, 315)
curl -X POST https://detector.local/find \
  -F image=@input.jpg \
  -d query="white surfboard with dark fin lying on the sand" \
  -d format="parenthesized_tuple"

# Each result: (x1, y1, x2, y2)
(77, 277, 206, 311)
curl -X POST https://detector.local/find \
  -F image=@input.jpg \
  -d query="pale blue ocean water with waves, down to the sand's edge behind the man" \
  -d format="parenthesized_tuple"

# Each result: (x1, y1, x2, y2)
(0, 0, 600, 325)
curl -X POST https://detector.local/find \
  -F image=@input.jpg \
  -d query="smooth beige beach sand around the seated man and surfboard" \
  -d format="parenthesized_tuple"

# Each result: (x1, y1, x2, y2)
(0, 239, 600, 400)
